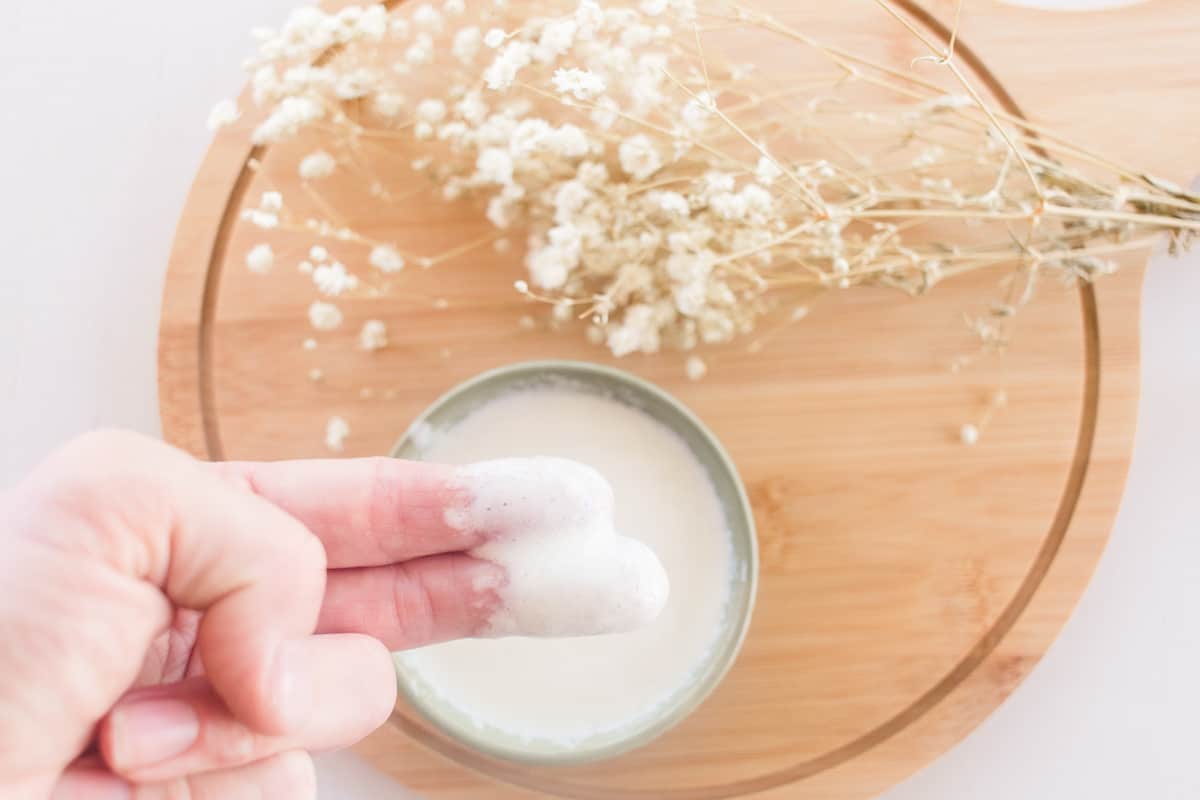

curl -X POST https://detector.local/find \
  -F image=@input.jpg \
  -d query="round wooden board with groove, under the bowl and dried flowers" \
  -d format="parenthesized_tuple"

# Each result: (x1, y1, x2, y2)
(160, 0, 1200, 799)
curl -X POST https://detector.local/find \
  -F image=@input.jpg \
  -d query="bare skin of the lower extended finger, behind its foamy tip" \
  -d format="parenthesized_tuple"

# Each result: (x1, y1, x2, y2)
(317, 553, 506, 650)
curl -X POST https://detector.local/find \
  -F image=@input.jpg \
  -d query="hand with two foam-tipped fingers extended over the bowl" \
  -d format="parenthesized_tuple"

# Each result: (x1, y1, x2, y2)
(0, 432, 516, 800)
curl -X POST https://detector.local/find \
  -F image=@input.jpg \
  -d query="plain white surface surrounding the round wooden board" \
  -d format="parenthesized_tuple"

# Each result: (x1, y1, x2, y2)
(0, 0, 1200, 800)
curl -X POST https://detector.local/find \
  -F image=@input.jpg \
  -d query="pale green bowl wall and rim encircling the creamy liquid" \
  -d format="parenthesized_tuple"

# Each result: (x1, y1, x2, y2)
(391, 361, 758, 764)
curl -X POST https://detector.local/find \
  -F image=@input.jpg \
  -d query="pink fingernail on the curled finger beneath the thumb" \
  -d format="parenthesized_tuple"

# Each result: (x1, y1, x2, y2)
(109, 697, 200, 769)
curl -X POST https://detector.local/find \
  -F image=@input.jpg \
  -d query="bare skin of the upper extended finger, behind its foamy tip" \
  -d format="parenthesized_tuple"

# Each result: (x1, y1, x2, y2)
(212, 458, 482, 567)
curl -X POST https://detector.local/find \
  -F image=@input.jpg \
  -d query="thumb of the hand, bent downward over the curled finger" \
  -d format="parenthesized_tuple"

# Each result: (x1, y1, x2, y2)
(27, 432, 325, 733)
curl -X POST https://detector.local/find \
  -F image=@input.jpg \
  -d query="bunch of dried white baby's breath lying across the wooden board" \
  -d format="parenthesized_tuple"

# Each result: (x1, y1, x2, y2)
(226, 0, 1200, 376)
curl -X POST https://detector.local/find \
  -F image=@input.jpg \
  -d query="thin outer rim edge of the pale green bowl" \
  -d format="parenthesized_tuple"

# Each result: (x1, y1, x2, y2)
(388, 359, 758, 766)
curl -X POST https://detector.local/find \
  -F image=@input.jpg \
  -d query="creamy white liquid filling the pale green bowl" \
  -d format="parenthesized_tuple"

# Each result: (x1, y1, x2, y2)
(400, 387, 733, 744)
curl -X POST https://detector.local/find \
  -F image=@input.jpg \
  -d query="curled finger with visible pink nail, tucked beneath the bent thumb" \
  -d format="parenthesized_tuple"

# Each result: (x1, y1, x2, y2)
(98, 634, 396, 783)
